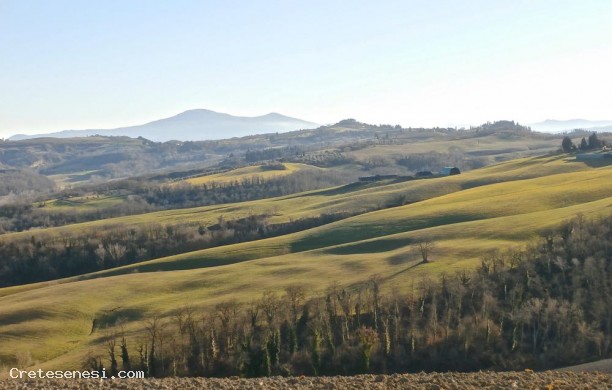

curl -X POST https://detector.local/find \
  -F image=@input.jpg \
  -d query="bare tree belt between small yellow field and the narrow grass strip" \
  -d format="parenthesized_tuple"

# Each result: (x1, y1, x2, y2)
(0, 169, 347, 233)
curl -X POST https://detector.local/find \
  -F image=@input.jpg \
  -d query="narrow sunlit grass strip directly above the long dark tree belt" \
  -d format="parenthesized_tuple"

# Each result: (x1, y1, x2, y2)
(0, 156, 588, 242)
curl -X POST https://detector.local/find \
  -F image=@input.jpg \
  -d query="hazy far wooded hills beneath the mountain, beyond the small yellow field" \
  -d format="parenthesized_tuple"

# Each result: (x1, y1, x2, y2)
(0, 120, 580, 187)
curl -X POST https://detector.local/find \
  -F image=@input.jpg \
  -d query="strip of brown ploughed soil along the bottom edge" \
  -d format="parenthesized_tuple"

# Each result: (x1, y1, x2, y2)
(0, 371, 612, 390)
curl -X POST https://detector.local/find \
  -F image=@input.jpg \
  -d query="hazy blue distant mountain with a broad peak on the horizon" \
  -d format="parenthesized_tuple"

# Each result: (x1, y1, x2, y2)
(9, 109, 318, 141)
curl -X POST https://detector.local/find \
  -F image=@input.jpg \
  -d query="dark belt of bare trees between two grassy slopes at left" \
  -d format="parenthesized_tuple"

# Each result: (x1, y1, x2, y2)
(0, 212, 354, 287)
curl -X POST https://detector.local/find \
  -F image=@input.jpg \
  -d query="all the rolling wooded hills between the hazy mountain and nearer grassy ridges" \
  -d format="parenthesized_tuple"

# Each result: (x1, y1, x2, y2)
(0, 119, 580, 239)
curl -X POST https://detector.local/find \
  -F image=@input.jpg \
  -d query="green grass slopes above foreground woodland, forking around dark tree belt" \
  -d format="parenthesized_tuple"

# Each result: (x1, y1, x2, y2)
(0, 156, 612, 368)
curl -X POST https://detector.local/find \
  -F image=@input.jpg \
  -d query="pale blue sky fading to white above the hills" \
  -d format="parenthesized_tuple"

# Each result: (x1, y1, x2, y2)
(0, 0, 612, 137)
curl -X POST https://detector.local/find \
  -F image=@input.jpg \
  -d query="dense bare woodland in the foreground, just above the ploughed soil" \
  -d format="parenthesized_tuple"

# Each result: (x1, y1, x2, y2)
(85, 216, 612, 377)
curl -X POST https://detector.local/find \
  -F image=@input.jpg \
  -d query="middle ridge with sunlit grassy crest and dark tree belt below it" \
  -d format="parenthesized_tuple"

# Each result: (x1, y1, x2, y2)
(0, 158, 588, 284)
